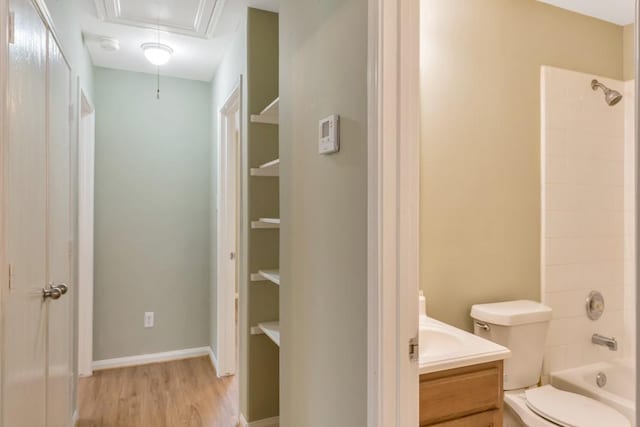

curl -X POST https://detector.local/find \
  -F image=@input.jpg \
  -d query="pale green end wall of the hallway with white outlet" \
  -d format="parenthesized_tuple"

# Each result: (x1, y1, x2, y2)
(94, 68, 211, 360)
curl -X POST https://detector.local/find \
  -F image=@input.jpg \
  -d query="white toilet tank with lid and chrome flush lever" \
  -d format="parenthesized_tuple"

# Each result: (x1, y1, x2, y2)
(471, 300, 551, 390)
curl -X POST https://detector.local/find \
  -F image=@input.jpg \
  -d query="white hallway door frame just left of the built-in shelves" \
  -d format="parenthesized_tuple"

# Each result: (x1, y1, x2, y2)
(216, 76, 242, 377)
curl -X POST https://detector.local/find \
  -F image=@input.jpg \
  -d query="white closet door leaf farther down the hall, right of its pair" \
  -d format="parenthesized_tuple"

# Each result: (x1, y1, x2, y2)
(47, 33, 73, 427)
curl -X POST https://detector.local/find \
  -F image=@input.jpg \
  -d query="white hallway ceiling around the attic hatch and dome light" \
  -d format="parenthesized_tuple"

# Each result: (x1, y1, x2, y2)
(80, 0, 278, 81)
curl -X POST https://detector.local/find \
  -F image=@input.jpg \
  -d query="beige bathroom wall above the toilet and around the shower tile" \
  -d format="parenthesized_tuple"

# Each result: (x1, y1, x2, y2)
(421, 0, 623, 328)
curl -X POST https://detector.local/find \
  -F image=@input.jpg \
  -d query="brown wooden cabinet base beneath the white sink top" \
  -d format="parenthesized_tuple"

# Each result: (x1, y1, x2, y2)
(420, 360, 503, 427)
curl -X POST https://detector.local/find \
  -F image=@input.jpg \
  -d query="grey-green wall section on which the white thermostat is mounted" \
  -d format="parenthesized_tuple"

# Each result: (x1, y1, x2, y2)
(280, 0, 368, 427)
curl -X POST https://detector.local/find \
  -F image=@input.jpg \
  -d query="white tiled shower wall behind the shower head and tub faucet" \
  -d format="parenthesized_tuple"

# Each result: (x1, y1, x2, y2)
(541, 67, 633, 374)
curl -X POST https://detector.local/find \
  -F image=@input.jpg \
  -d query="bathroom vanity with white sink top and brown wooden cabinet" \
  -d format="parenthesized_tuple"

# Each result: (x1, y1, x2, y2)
(420, 318, 511, 427)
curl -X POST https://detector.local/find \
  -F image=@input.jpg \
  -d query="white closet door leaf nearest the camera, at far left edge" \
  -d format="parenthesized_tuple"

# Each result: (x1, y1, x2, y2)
(2, 0, 47, 427)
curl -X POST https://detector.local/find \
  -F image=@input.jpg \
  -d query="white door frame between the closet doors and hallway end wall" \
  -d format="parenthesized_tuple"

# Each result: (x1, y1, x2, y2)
(76, 88, 95, 377)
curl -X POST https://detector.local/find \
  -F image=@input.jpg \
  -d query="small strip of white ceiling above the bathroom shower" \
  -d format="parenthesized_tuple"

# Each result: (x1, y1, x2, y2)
(538, 0, 635, 25)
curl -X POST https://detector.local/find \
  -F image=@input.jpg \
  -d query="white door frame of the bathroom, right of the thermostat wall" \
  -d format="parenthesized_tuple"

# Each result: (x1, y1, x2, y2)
(367, 0, 420, 427)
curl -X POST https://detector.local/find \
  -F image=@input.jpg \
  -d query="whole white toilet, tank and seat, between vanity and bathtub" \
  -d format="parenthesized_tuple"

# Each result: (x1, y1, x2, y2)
(471, 300, 631, 427)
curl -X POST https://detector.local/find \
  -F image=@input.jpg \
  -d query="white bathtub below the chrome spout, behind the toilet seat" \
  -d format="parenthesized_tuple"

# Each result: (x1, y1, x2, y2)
(551, 361, 636, 426)
